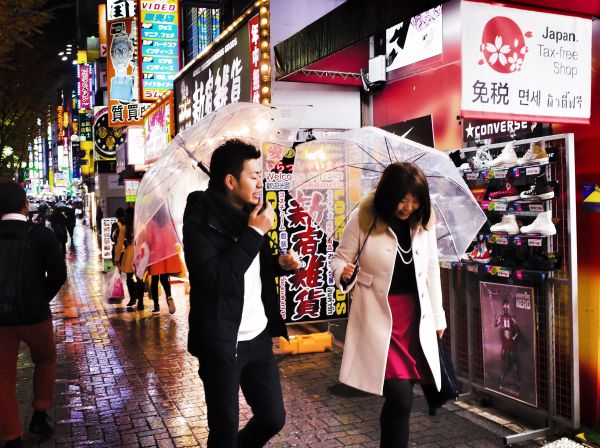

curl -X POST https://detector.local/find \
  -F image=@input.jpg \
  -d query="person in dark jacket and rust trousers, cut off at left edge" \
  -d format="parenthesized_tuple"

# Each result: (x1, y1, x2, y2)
(0, 182, 67, 447)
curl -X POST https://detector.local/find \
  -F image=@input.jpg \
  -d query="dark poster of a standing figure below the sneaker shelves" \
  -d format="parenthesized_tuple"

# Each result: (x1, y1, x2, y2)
(479, 282, 537, 406)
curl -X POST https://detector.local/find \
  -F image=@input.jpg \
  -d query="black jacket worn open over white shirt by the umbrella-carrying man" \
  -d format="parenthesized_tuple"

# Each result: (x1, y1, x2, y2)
(183, 188, 287, 361)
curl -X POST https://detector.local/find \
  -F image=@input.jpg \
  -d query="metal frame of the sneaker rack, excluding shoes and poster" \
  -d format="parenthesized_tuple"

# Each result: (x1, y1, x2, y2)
(441, 134, 580, 445)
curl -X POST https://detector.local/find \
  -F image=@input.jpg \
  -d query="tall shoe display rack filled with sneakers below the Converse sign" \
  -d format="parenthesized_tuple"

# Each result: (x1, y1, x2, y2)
(440, 134, 580, 445)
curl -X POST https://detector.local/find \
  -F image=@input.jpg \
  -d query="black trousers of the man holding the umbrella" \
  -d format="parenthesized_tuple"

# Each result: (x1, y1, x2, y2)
(199, 330, 285, 448)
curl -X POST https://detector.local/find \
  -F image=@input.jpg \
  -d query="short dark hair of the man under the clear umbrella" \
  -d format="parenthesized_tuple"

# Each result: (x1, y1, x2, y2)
(208, 139, 260, 192)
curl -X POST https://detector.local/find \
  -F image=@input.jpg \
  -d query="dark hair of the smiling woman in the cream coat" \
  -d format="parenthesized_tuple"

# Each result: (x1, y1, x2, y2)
(373, 162, 431, 227)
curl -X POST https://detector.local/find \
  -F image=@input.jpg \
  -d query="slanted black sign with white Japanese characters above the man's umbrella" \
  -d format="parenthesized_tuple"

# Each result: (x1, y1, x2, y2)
(174, 16, 255, 132)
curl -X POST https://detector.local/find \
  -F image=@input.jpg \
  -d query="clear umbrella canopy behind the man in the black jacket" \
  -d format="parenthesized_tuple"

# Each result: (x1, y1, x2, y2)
(134, 103, 303, 275)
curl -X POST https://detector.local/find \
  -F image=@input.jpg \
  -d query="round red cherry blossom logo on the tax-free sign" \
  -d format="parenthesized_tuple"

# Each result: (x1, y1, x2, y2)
(479, 17, 533, 73)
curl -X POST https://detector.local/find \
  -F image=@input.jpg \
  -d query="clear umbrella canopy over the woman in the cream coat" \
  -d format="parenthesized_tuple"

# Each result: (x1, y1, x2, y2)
(292, 127, 486, 260)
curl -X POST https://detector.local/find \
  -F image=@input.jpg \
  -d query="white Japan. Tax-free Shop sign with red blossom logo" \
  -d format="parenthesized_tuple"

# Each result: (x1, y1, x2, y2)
(461, 1, 592, 123)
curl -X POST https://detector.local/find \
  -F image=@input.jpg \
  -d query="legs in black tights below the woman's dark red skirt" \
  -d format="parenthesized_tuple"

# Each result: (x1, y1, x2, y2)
(380, 378, 413, 448)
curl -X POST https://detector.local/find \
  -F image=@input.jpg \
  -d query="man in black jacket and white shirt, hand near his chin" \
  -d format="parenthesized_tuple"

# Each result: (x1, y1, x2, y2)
(183, 140, 301, 448)
